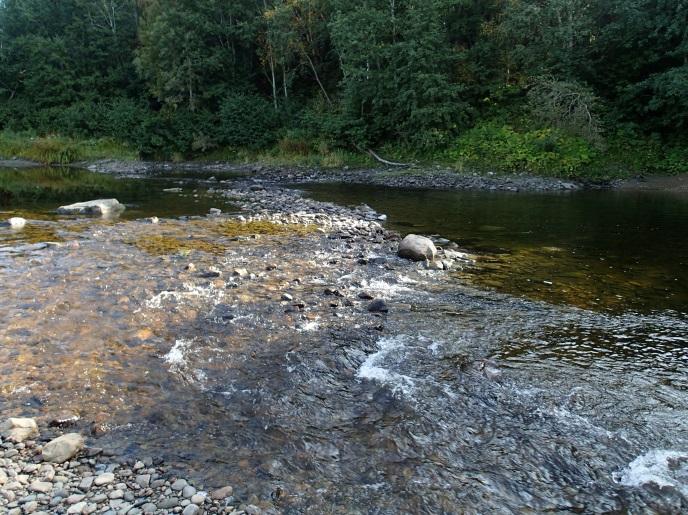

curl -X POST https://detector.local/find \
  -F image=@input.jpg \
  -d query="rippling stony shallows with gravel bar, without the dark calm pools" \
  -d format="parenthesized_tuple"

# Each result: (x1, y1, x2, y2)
(0, 175, 688, 513)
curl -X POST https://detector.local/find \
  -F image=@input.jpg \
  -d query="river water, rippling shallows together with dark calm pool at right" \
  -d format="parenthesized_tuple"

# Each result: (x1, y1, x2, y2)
(0, 168, 688, 514)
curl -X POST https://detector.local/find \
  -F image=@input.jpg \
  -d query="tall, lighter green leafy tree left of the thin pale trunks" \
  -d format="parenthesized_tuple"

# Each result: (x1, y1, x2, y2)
(135, 0, 258, 111)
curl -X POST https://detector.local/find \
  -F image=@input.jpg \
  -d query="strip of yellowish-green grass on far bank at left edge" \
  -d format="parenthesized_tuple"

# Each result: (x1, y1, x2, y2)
(0, 130, 138, 165)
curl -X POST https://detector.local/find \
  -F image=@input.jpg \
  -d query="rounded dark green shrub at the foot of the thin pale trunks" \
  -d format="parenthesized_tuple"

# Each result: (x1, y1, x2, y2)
(218, 93, 280, 149)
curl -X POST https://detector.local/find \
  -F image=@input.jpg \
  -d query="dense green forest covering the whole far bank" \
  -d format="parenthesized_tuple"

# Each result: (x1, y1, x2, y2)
(0, 0, 688, 175)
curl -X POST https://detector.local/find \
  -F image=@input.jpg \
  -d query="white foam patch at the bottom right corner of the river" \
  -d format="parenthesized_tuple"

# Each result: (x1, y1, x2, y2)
(618, 449, 688, 496)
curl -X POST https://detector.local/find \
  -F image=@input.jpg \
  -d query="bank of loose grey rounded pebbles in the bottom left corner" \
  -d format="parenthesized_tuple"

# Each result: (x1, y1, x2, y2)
(0, 418, 258, 515)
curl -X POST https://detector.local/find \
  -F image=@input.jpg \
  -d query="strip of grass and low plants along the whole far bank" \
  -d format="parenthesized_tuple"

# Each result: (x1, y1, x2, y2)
(0, 131, 688, 183)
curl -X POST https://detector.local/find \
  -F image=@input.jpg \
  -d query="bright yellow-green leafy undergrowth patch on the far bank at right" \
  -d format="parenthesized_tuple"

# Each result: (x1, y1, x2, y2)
(447, 122, 598, 176)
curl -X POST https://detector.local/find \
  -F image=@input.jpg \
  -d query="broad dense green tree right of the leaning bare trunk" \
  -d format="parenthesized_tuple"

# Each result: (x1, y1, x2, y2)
(331, 0, 467, 146)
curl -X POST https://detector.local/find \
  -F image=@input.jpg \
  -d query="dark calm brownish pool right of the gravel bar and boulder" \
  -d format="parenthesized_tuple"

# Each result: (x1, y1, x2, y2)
(303, 184, 688, 313)
